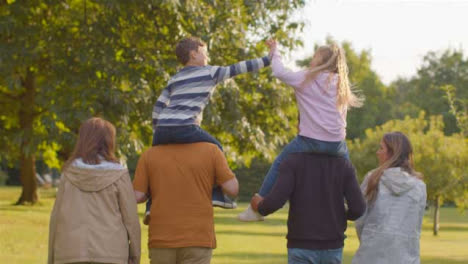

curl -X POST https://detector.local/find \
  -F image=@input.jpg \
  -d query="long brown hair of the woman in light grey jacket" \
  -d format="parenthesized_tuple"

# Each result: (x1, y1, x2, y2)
(364, 132, 422, 202)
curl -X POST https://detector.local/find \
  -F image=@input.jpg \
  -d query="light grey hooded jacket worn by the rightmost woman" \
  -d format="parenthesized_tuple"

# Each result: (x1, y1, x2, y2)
(352, 168, 426, 264)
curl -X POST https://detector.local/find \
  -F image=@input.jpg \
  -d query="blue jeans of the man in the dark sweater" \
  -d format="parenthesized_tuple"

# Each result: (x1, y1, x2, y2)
(288, 248, 343, 264)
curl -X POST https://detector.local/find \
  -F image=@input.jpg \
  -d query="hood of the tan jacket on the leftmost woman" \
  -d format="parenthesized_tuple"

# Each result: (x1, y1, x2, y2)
(63, 165, 128, 192)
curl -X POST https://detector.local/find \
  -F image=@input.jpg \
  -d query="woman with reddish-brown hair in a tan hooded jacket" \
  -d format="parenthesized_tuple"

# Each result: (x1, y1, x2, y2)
(48, 118, 140, 264)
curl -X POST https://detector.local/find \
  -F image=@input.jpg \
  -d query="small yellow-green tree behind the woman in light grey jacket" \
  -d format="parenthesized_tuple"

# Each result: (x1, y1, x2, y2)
(349, 112, 468, 235)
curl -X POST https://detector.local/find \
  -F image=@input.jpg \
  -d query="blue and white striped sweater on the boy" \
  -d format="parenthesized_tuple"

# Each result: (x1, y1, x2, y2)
(153, 56, 270, 132)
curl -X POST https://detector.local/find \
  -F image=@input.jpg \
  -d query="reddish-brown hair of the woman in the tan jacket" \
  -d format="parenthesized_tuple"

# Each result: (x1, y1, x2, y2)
(63, 117, 118, 168)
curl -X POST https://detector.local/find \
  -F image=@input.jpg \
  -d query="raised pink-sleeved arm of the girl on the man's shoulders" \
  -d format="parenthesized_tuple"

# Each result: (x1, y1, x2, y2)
(266, 40, 306, 88)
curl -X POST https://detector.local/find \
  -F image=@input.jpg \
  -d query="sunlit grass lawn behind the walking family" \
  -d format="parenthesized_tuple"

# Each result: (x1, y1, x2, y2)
(0, 187, 468, 264)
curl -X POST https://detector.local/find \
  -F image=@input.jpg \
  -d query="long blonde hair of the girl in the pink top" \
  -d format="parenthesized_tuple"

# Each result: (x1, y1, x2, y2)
(304, 43, 364, 109)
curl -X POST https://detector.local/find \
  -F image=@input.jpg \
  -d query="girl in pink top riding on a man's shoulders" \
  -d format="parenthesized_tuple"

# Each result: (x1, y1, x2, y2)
(238, 40, 363, 221)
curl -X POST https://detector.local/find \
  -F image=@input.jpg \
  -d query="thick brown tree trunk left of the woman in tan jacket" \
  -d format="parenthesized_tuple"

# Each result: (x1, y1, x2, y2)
(16, 69, 38, 205)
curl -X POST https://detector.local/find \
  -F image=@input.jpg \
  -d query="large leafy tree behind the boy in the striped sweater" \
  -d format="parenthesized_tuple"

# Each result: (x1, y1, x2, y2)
(0, 0, 304, 204)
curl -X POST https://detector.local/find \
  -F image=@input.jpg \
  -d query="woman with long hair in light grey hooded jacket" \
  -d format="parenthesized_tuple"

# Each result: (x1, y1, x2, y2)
(352, 132, 426, 264)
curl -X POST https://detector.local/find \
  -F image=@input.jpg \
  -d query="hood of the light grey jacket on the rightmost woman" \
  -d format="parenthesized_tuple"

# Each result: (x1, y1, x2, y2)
(380, 167, 417, 195)
